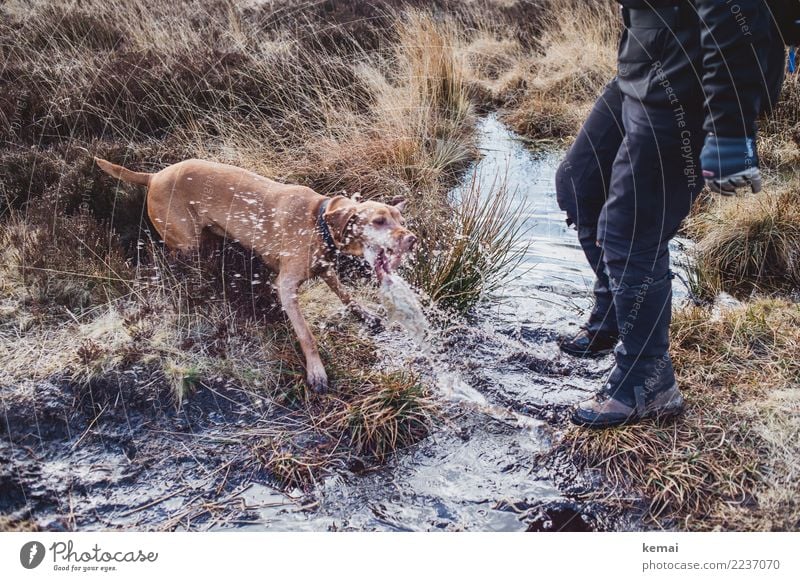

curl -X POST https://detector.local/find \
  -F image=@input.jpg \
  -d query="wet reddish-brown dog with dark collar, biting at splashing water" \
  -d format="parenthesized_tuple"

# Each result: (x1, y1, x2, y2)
(95, 158, 417, 392)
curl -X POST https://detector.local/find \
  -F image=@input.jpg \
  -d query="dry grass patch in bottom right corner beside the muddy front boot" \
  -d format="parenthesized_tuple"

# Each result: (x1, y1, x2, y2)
(564, 299, 800, 530)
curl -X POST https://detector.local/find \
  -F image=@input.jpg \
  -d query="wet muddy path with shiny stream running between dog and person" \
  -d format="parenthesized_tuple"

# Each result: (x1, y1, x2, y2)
(0, 116, 683, 531)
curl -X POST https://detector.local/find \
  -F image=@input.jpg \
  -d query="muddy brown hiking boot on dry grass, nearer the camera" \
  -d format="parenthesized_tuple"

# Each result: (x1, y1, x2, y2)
(572, 383, 685, 428)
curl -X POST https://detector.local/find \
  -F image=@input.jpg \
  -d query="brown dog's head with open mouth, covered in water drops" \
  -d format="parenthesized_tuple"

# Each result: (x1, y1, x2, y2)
(324, 196, 417, 282)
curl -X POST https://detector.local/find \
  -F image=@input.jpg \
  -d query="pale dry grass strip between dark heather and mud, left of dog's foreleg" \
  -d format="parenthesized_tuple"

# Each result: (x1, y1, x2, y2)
(0, 288, 288, 396)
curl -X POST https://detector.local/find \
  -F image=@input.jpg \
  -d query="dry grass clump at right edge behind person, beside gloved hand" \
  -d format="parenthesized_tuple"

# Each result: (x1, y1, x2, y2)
(687, 60, 800, 300)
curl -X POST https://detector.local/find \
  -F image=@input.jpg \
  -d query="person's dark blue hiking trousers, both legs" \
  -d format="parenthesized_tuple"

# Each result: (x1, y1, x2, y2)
(556, 79, 704, 404)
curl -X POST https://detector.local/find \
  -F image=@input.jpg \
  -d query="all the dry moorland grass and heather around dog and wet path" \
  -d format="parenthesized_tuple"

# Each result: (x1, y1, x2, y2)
(0, 0, 800, 530)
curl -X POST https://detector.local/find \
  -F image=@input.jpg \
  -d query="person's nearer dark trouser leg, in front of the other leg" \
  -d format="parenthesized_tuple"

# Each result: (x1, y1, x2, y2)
(599, 97, 703, 405)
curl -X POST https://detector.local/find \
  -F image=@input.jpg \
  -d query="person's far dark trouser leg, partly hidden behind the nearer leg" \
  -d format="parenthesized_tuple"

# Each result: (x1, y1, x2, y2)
(556, 81, 624, 334)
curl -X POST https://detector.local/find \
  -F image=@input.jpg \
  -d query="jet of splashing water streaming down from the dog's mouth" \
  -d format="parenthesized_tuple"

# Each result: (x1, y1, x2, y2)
(380, 274, 541, 429)
